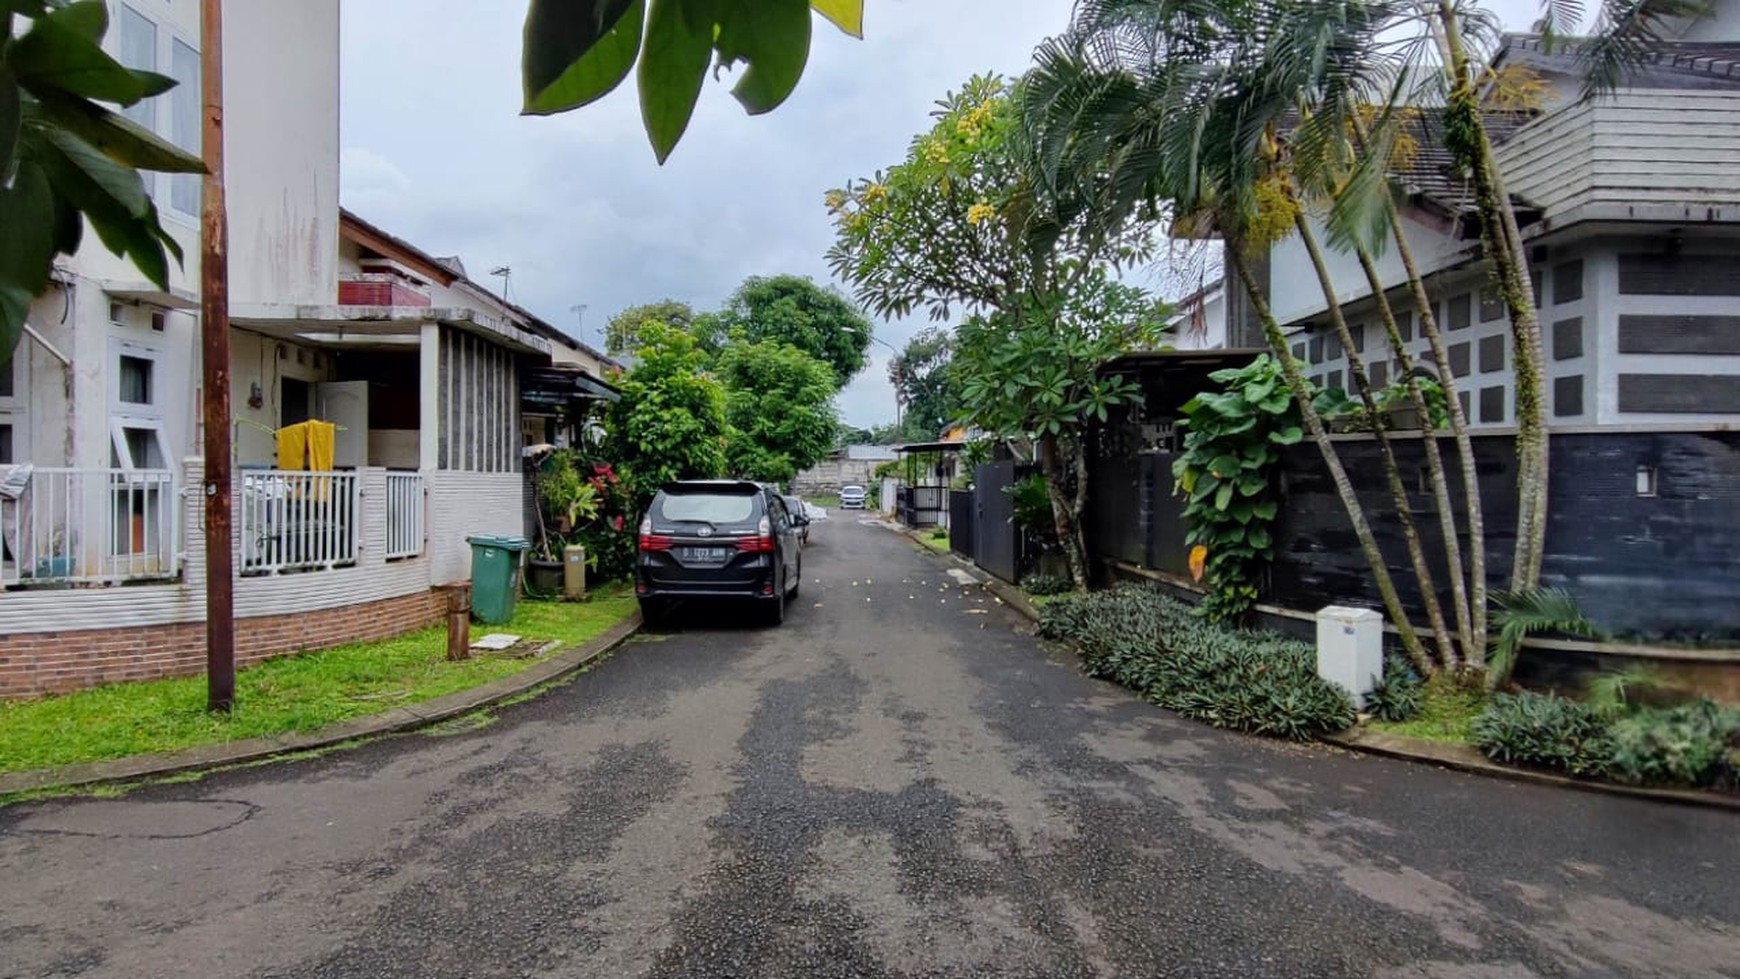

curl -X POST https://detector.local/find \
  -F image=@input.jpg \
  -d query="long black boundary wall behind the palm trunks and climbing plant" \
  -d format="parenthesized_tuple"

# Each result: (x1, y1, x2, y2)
(1088, 431, 1740, 640)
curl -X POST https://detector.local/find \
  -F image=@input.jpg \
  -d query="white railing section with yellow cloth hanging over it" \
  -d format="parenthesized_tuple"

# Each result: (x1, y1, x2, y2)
(235, 470, 360, 574)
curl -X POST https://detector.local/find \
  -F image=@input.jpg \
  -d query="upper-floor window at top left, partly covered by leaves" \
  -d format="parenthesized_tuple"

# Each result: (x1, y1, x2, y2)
(113, 3, 200, 217)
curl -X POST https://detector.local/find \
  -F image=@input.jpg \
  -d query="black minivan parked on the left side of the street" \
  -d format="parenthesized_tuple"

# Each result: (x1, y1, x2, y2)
(635, 480, 809, 624)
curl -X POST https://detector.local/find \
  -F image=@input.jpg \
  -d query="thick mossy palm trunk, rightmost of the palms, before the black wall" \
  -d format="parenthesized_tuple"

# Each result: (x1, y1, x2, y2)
(1437, 0, 1549, 589)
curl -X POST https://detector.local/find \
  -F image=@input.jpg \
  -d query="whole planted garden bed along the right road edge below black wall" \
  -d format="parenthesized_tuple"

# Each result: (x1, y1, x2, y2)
(1039, 584, 1740, 791)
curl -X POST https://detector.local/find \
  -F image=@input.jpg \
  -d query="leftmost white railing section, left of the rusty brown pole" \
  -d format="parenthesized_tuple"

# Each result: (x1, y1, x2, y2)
(0, 468, 181, 586)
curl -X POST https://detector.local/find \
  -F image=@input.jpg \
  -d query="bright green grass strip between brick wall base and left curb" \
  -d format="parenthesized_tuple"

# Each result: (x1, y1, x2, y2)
(0, 584, 635, 772)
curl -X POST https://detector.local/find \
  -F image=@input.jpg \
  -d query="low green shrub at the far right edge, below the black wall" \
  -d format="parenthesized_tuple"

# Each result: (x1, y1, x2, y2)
(1611, 699, 1740, 788)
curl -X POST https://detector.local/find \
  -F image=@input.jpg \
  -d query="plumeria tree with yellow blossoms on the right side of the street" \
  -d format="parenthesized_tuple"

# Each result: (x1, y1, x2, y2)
(827, 75, 1161, 588)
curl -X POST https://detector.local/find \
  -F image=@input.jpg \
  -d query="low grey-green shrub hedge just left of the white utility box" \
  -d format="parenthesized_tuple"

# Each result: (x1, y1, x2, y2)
(1041, 584, 1354, 741)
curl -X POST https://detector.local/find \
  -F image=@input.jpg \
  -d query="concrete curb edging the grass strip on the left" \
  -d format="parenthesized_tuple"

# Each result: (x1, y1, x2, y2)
(0, 612, 640, 796)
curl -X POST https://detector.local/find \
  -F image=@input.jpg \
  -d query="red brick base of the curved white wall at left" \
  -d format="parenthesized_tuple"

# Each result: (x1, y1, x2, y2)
(0, 591, 445, 697)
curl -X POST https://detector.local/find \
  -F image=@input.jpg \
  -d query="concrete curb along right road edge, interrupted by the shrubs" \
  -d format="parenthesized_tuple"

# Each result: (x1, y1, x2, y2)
(894, 523, 1740, 812)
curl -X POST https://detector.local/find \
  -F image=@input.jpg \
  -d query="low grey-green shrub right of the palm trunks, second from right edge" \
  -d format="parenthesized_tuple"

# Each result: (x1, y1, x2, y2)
(1474, 694, 1613, 776)
